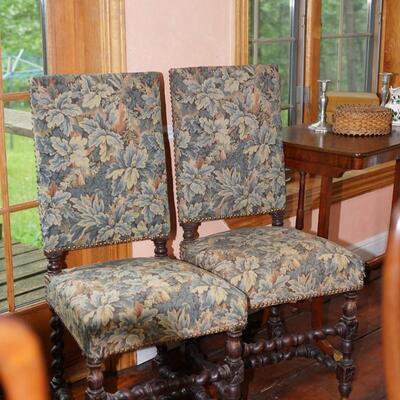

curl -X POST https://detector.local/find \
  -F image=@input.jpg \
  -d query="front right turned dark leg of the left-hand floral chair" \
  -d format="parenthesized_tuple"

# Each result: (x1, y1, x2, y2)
(223, 331, 244, 400)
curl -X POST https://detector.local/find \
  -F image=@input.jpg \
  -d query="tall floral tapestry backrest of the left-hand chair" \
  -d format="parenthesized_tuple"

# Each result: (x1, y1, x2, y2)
(30, 73, 169, 252)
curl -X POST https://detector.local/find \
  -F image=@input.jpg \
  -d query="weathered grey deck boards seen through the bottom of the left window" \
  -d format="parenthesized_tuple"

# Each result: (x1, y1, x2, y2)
(0, 241, 47, 312)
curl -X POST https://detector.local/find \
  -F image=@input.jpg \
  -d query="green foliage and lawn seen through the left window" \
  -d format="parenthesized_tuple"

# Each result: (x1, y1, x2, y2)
(0, 0, 43, 247)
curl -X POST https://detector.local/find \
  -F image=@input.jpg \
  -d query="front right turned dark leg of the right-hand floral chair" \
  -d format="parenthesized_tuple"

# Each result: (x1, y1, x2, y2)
(336, 292, 358, 400)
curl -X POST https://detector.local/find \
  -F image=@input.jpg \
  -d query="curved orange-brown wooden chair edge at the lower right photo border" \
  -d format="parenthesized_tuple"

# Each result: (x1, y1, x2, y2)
(382, 203, 400, 400)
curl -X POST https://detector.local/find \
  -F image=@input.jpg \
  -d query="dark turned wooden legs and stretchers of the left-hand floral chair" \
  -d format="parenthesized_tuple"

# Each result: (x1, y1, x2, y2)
(46, 239, 244, 400)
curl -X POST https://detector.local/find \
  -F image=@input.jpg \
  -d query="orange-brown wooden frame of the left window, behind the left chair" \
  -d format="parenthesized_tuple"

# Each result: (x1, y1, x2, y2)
(0, 0, 136, 381)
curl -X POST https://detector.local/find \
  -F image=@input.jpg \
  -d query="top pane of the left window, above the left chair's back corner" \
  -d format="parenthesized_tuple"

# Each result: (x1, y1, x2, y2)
(0, 0, 43, 92)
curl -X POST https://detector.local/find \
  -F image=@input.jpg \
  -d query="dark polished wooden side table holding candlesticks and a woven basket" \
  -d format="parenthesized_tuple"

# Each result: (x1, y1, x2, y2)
(283, 125, 400, 329)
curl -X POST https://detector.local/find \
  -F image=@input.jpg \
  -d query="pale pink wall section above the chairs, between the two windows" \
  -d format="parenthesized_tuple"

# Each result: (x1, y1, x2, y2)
(125, 0, 235, 117)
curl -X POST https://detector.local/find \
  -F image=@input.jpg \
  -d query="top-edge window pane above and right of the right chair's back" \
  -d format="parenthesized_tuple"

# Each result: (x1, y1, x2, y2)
(258, 0, 291, 39)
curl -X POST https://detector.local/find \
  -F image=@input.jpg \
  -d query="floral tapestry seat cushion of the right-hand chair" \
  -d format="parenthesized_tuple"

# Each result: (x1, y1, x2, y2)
(181, 226, 364, 309)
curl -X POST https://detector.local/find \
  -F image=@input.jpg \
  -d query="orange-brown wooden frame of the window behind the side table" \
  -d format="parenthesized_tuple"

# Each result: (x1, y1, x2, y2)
(233, 0, 400, 219)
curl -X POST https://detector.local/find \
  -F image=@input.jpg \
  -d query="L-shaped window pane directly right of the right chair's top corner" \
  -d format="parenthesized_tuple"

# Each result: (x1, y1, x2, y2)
(258, 42, 290, 106)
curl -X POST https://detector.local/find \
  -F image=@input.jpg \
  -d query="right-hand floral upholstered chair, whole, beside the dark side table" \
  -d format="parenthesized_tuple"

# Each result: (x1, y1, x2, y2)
(170, 65, 364, 399)
